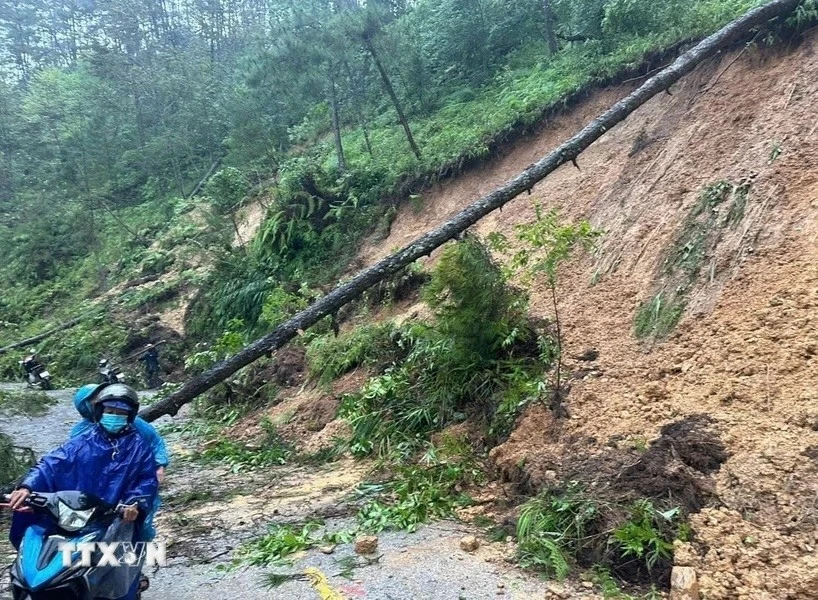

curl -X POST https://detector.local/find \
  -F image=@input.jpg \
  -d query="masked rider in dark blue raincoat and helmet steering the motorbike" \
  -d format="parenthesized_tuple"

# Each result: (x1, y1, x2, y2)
(9, 384, 159, 600)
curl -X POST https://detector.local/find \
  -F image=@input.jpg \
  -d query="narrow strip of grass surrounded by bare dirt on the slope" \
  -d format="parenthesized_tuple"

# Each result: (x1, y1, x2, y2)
(634, 179, 752, 338)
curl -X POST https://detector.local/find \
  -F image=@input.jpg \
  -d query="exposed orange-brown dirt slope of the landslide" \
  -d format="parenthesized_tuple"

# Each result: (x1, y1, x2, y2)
(361, 32, 818, 600)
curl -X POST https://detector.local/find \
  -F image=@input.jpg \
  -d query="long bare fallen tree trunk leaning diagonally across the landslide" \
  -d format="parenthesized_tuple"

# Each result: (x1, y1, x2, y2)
(141, 0, 801, 421)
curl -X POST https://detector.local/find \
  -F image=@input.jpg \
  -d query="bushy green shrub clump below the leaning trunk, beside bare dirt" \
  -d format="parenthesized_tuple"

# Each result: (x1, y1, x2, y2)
(334, 236, 544, 457)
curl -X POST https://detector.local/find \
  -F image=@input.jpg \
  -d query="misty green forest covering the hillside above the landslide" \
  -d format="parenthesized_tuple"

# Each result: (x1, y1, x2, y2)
(0, 0, 792, 342)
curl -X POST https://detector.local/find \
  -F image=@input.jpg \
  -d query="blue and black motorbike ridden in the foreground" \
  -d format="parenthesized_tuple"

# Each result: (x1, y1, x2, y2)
(2, 491, 145, 600)
